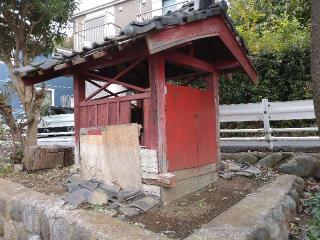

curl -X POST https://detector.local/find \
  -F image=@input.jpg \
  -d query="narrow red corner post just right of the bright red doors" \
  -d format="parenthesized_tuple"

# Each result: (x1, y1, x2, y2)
(206, 72, 221, 161)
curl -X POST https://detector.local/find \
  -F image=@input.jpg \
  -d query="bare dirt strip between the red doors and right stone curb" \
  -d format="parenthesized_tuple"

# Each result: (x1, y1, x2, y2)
(128, 177, 265, 239)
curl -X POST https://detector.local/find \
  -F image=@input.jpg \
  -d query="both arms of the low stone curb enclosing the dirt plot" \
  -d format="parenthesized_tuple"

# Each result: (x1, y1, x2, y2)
(0, 175, 304, 240)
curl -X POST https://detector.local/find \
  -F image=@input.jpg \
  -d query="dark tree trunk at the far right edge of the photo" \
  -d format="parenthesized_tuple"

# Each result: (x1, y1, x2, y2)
(311, 0, 320, 132)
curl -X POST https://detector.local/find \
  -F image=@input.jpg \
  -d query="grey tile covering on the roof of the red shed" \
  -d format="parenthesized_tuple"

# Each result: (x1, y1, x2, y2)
(14, 0, 247, 77)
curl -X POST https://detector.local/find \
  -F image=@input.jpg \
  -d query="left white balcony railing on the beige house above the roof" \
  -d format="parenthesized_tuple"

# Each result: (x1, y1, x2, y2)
(73, 23, 121, 51)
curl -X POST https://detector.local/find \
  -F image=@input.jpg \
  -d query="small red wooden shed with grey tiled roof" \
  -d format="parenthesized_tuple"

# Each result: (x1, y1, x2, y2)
(16, 1, 258, 201)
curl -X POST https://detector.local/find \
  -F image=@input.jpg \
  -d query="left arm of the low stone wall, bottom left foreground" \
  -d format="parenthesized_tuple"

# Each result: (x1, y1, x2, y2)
(0, 179, 168, 240)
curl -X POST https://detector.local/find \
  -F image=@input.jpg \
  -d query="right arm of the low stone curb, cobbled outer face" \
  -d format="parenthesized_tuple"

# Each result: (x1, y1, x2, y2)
(187, 175, 303, 240)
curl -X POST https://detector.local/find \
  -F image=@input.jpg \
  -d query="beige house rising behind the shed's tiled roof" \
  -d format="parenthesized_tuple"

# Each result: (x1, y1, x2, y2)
(73, 0, 188, 51)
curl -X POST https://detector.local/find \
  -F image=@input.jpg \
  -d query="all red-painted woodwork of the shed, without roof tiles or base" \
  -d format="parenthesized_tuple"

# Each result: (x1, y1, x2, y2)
(24, 16, 258, 173)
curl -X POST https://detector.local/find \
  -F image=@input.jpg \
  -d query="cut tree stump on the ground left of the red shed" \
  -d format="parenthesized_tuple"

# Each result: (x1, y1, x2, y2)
(23, 145, 74, 171)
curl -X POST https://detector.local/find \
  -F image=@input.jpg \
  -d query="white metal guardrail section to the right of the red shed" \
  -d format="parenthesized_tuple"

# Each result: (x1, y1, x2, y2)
(220, 99, 319, 149)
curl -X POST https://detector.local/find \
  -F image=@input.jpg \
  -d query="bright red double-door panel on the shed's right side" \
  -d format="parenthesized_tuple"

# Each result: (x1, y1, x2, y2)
(166, 84, 218, 171)
